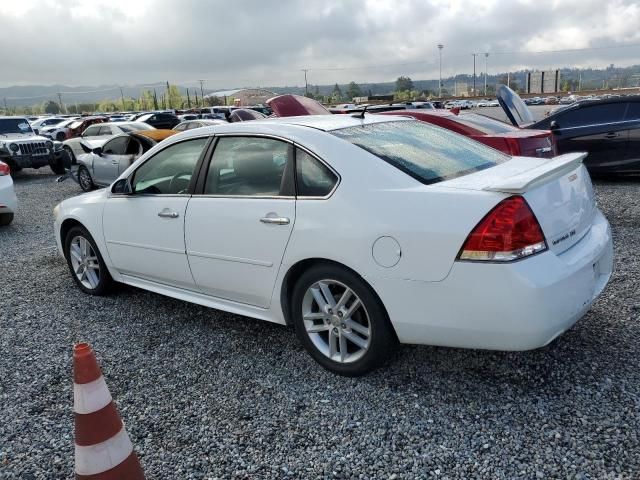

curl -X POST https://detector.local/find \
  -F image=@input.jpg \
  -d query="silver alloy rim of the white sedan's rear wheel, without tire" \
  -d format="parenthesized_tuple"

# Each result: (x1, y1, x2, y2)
(302, 279, 371, 363)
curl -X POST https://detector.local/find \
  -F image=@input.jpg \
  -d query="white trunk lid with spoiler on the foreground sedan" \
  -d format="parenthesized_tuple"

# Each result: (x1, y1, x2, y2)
(438, 153, 596, 253)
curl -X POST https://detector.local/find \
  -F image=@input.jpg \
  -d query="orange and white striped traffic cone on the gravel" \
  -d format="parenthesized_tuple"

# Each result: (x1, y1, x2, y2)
(73, 343, 144, 480)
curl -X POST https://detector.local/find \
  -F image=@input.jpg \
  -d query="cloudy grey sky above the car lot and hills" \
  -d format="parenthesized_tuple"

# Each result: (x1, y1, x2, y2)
(0, 0, 640, 89)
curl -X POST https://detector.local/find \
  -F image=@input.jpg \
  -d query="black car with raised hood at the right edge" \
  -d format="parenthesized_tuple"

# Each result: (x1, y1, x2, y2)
(498, 85, 640, 175)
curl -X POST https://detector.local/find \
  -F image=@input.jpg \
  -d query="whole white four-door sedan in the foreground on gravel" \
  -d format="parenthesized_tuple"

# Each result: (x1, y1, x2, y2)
(54, 115, 612, 375)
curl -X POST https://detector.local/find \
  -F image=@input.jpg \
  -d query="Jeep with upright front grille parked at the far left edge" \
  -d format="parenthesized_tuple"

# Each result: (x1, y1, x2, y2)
(0, 117, 64, 173)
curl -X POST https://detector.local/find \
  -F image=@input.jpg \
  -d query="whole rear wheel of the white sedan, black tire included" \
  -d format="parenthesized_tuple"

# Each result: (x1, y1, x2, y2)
(291, 264, 398, 377)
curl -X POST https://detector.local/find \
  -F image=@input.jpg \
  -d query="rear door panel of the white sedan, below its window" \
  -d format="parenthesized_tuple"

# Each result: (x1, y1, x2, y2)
(185, 197, 295, 308)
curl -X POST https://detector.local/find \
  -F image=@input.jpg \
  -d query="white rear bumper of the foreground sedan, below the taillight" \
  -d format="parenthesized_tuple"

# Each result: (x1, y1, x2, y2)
(368, 211, 613, 350)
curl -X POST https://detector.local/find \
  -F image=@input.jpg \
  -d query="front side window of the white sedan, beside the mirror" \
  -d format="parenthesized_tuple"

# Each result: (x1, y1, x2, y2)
(132, 138, 207, 195)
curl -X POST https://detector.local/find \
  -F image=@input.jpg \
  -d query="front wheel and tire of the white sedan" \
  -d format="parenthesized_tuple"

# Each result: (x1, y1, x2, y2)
(64, 226, 114, 296)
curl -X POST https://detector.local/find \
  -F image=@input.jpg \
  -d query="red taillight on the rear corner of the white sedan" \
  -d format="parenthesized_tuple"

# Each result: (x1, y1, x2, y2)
(458, 196, 547, 262)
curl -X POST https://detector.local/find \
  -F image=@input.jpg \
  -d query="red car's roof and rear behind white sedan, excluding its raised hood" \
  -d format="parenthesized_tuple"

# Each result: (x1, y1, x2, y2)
(378, 110, 557, 158)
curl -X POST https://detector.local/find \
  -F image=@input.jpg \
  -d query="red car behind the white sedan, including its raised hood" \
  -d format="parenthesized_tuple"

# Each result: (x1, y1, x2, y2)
(267, 95, 556, 157)
